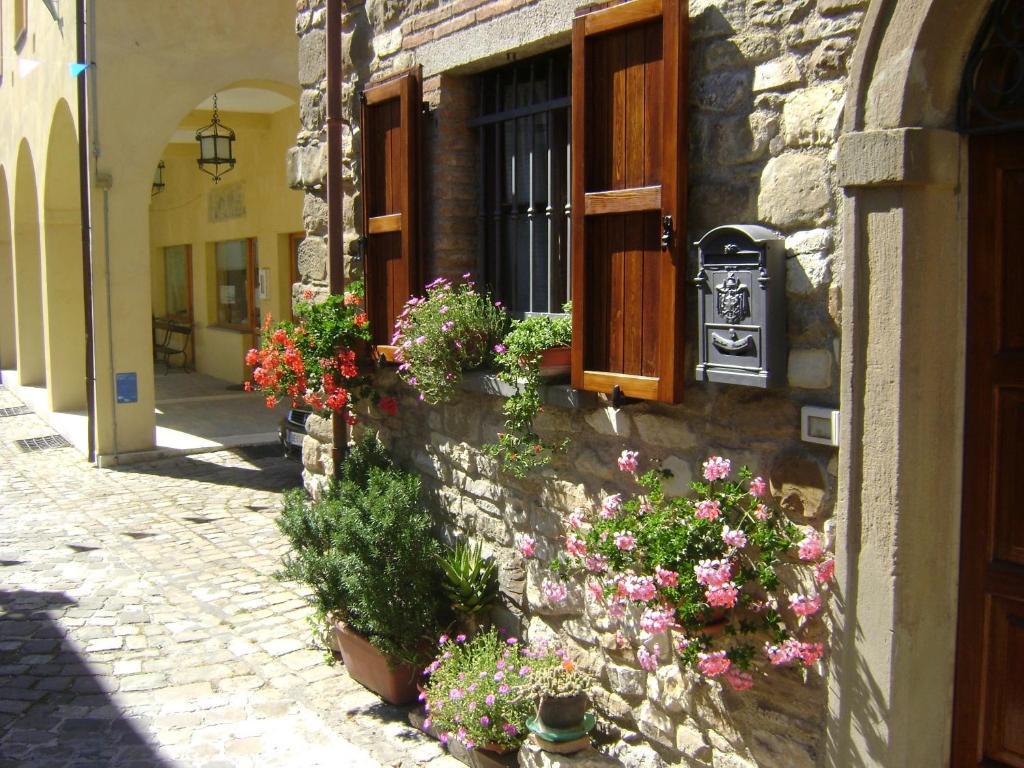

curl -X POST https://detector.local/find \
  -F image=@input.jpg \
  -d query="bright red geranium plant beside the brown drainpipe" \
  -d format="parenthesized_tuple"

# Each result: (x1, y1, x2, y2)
(245, 283, 393, 423)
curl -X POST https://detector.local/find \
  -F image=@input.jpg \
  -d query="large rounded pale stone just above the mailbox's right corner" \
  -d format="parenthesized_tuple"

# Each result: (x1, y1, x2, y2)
(758, 155, 831, 230)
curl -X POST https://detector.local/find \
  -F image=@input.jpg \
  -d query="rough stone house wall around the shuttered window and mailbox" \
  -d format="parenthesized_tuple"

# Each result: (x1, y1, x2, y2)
(292, 0, 866, 768)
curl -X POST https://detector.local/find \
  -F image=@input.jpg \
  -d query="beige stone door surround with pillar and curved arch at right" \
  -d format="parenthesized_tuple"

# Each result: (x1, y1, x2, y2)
(828, 0, 989, 768)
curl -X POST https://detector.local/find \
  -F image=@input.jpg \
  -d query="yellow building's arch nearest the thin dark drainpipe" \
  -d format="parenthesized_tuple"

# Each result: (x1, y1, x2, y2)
(42, 99, 86, 411)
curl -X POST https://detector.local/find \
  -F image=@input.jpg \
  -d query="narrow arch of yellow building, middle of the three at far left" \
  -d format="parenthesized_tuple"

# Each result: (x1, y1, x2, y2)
(14, 140, 46, 386)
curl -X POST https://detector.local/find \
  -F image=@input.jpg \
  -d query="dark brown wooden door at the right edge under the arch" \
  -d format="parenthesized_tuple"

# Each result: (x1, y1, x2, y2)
(952, 133, 1024, 768)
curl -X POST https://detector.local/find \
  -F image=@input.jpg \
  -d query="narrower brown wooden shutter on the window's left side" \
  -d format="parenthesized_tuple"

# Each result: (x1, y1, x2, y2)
(360, 68, 423, 359)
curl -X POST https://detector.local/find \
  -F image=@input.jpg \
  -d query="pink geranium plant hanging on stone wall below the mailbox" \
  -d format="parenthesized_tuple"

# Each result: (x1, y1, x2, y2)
(555, 451, 834, 690)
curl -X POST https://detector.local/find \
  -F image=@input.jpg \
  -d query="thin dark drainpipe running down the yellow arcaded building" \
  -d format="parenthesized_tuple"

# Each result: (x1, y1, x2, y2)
(75, 0, 96, 463)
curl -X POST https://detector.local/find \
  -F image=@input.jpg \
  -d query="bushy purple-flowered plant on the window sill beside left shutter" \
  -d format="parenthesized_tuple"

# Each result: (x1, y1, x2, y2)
(391, 274, 508, 404)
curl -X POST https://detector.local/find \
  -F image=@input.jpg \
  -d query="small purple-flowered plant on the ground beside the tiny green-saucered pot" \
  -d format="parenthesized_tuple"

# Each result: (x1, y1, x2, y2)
(423, 630, 532, 753)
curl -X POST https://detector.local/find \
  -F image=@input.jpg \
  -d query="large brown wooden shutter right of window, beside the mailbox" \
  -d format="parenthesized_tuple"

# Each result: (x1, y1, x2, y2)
(571, 0, 687, 402)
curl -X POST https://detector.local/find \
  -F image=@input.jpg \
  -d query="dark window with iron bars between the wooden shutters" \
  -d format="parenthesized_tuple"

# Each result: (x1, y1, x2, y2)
(470, 48, 571, 315)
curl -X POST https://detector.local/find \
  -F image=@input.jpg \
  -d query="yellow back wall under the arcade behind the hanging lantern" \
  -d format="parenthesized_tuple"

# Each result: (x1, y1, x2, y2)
(150, 105, 302, 384)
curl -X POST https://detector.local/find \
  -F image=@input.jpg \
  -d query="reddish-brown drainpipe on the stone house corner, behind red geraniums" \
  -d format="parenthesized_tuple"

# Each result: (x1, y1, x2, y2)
(327, 0, 348, 477)
